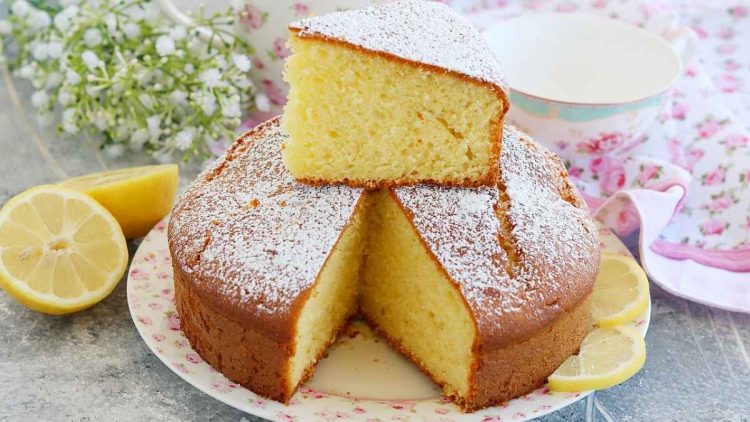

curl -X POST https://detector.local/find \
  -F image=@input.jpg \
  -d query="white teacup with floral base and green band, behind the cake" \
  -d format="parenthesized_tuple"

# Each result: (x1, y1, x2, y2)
(484, 14, 697, 155)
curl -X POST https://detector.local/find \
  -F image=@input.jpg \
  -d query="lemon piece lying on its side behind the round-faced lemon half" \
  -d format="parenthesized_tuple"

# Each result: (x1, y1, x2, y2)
(60, 164, 179, 239)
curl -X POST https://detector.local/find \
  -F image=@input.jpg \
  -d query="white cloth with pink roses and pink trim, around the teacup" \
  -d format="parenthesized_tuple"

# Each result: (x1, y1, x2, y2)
(464, 0, 750, 312)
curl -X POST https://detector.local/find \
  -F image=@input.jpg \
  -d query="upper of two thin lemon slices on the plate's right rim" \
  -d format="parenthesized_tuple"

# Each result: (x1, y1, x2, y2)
(591, 255, 649, 327)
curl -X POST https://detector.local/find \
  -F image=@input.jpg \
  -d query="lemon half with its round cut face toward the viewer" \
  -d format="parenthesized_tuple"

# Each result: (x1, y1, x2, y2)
(0, 185, 128, 315)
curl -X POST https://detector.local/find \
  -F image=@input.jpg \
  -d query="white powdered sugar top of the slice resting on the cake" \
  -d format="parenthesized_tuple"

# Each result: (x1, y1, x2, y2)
(289, 0, 505, 87)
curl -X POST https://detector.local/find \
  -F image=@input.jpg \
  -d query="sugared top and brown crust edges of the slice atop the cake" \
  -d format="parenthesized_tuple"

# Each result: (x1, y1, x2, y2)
(289, 0, 510, 189)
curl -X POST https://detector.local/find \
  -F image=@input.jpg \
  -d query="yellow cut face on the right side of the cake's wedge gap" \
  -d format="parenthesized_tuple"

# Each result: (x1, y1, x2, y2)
(360, 191, 476, 397)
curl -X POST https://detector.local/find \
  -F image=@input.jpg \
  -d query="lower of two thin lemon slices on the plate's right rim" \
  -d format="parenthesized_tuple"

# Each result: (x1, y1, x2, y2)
(549, 327, 646, 391)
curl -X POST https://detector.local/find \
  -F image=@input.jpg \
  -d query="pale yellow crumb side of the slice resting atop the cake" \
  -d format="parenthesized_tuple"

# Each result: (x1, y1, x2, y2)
(283, 35, 504, 185)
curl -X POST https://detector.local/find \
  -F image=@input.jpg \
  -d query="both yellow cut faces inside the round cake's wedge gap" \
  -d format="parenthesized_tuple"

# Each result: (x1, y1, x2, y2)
(289, 191, 476, 398)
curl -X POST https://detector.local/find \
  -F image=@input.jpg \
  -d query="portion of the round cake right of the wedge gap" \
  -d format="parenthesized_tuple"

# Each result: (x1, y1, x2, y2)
(359, 127, 599, 411)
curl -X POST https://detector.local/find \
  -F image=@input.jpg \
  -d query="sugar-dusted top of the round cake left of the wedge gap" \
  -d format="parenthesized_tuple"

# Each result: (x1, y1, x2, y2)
(170, 118, 362, 324)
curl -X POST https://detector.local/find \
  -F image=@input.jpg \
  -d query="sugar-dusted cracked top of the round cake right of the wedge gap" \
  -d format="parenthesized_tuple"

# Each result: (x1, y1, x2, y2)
(395, 126, 599, 345)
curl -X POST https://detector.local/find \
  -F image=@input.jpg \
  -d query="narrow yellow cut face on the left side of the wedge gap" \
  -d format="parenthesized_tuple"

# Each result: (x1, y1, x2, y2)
(289, 201, 367, 391)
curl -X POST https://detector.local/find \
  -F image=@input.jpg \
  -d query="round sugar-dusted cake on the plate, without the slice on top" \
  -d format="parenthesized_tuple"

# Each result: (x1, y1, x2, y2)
(168, 118, 599, 411)
